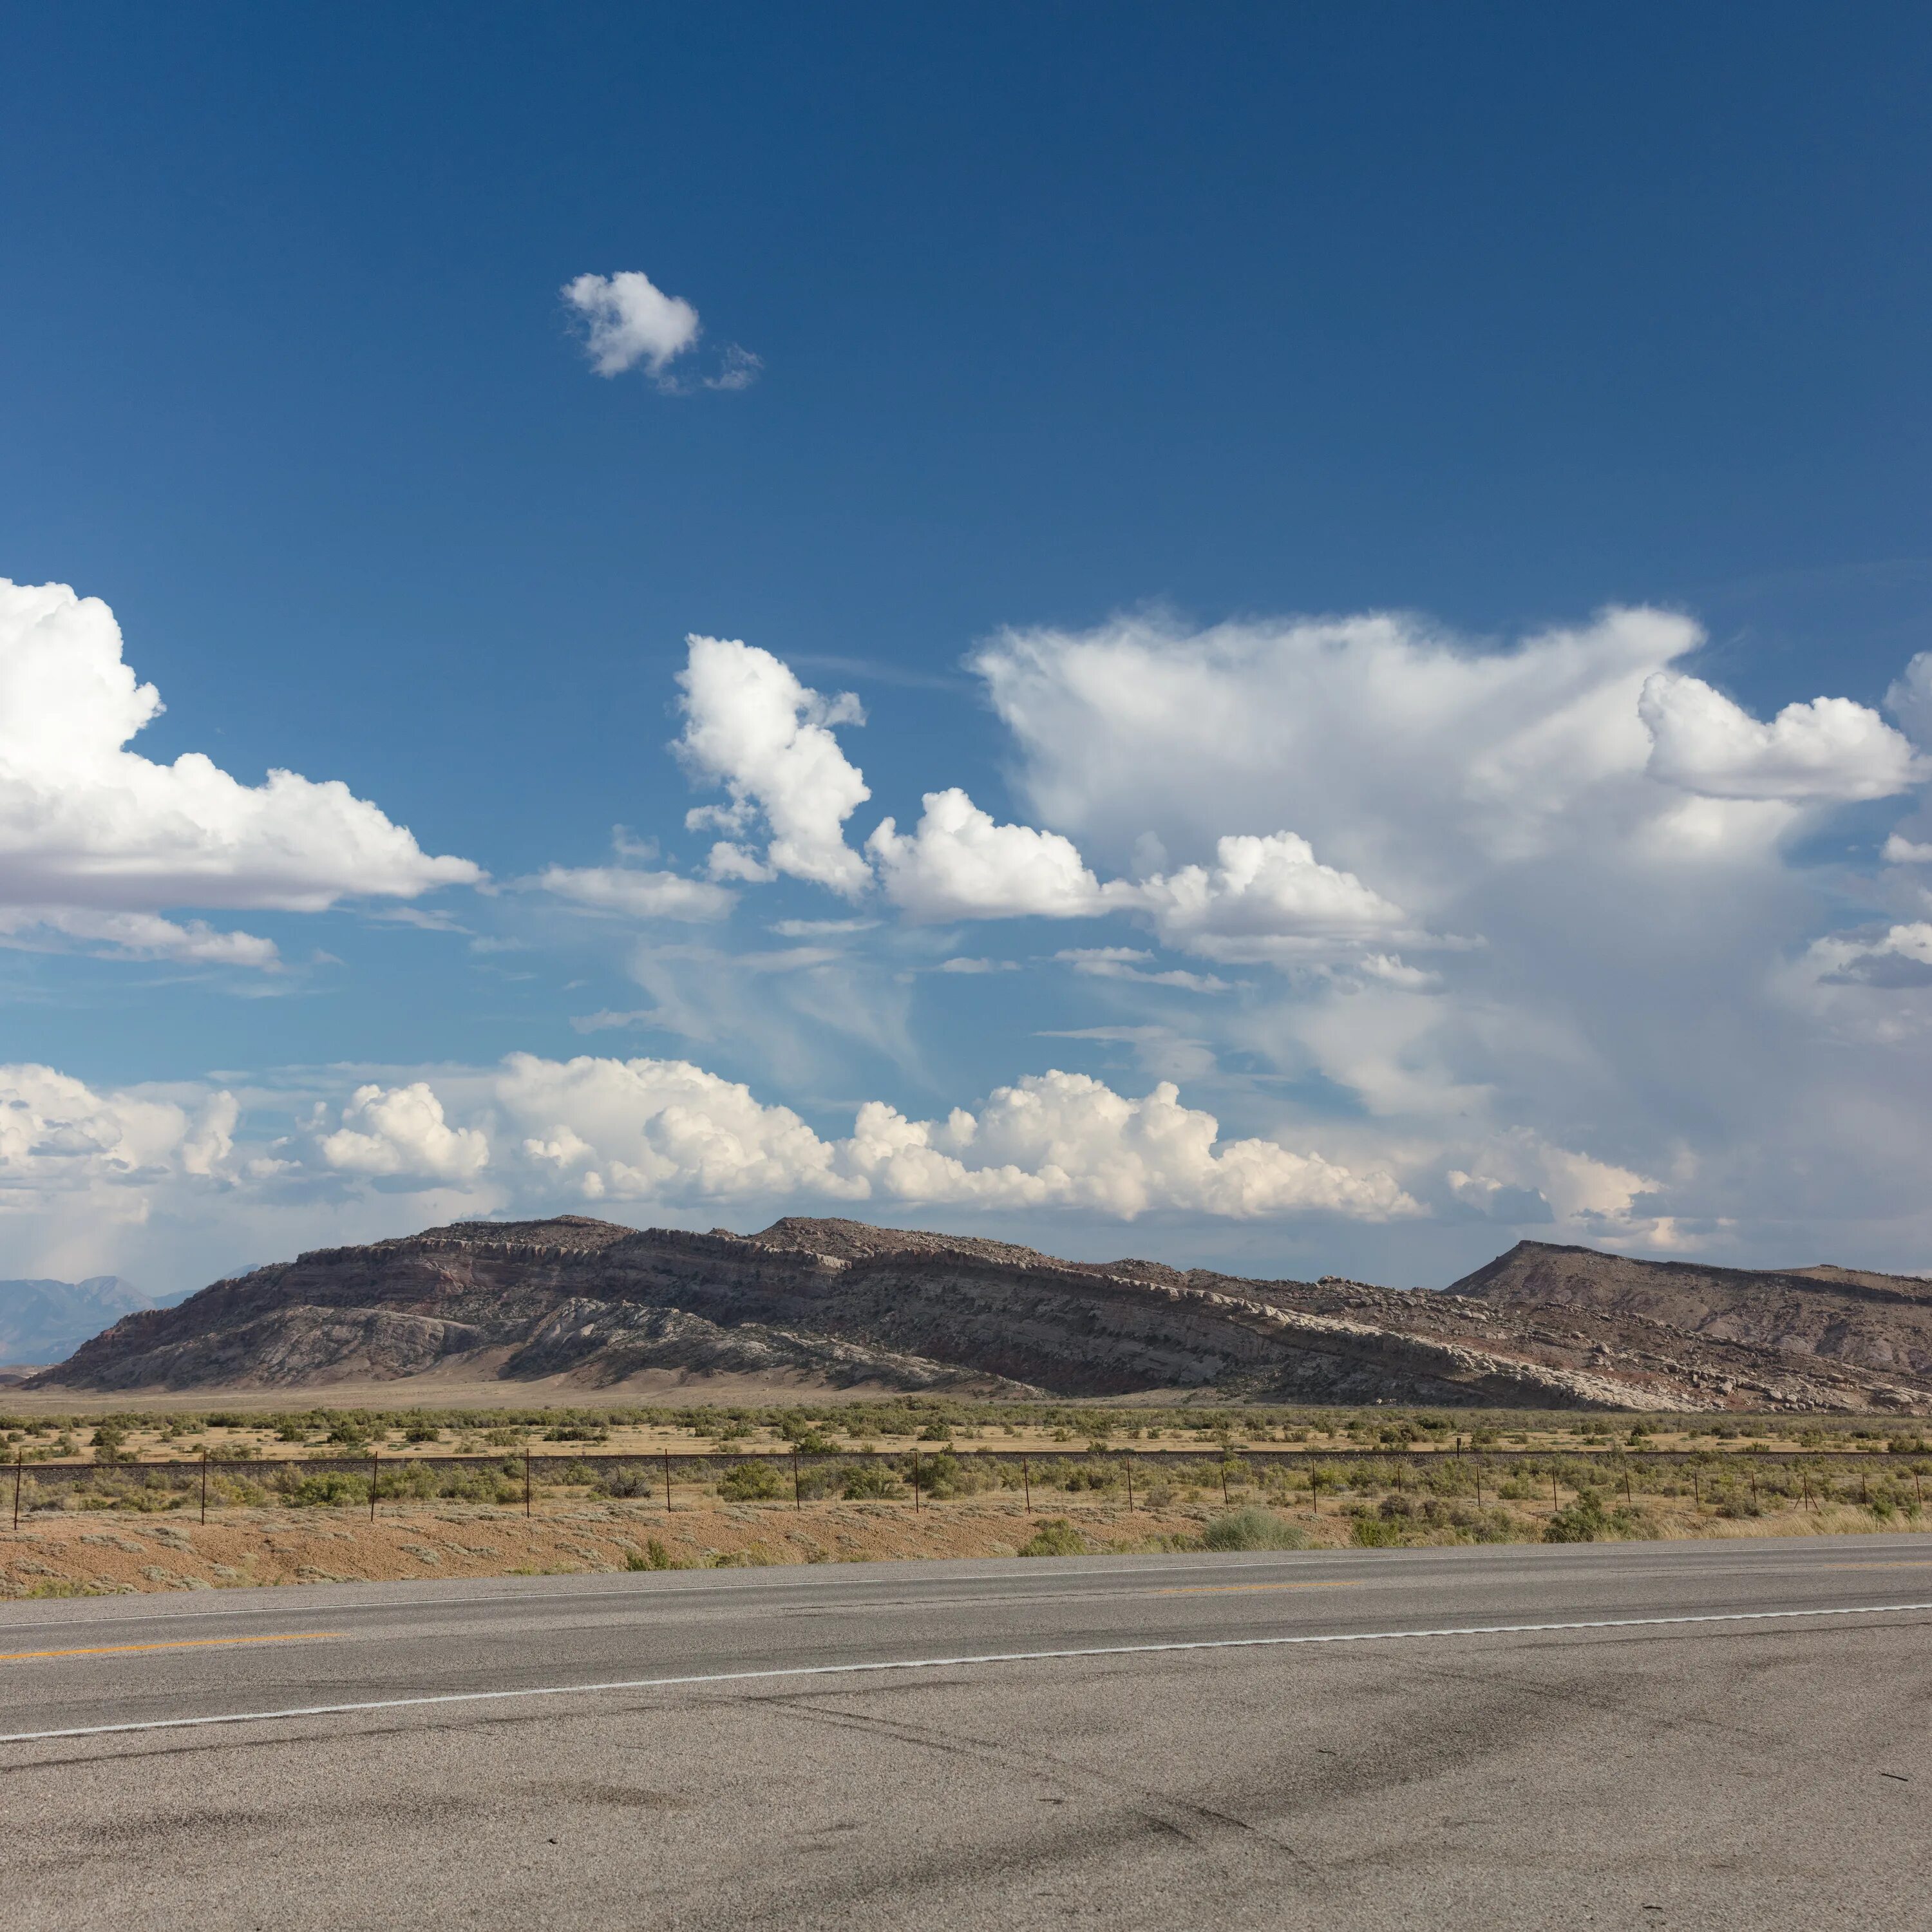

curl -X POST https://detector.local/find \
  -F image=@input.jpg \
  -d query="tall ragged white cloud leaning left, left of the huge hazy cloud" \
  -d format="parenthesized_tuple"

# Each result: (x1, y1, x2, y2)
(676, 636, 871, 896)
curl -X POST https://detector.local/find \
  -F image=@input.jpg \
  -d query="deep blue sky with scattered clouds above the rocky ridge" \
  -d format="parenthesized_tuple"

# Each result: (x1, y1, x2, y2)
(0, 6, 1932, 1287)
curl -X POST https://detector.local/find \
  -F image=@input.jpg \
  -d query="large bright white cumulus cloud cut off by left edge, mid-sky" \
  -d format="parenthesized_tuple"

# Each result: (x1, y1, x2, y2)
(0, 580, 483, 966)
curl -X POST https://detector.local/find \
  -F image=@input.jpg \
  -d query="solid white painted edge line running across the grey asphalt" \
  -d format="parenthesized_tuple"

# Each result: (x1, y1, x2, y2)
(0, 1604, 1932, 1745)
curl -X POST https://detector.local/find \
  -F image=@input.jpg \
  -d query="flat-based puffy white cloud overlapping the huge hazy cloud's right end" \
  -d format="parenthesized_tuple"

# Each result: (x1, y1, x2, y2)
(1636, 672, 1926, 802)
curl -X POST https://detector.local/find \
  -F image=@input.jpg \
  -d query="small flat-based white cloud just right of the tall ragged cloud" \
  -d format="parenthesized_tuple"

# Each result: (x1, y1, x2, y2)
(866, 786, 1103, 920)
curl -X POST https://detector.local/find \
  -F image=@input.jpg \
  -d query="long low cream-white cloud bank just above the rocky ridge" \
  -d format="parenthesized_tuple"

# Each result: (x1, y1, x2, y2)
(0, 1053, 1418, 1273)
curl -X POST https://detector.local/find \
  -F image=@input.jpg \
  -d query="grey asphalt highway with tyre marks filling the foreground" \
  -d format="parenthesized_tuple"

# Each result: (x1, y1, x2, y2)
(0, 1536, 1932, 1932)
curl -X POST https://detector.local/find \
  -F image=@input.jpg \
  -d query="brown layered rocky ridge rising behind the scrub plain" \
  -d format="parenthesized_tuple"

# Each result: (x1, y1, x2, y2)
(33, 1215, 1932, 1408)
